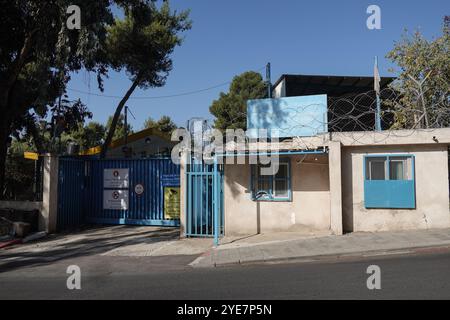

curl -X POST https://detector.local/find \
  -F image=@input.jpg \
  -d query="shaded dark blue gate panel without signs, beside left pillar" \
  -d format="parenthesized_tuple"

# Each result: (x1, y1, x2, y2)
(56, 158, 84, 231)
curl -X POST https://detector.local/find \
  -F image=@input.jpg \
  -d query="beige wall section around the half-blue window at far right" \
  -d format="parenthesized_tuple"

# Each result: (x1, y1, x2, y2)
(342, 144, 450, 232)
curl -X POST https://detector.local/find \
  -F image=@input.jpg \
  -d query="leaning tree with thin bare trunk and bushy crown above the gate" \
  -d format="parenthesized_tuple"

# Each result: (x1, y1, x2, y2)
(100, 1, 191, 157)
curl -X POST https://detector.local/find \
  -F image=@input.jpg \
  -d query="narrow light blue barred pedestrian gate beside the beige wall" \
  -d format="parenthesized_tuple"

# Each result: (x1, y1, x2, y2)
(186, 159, 224, 237)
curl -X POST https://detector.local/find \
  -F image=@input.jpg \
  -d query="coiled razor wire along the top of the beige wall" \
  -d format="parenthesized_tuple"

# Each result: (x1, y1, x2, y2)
(213, 78, 450, 144)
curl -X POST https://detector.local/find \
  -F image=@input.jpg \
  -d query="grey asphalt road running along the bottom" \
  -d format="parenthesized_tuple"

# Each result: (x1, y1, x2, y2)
(0, 252, 450, 300)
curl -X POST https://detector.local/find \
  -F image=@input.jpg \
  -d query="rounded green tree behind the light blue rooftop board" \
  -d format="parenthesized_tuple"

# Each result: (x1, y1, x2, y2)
(209, 71, 267, 130)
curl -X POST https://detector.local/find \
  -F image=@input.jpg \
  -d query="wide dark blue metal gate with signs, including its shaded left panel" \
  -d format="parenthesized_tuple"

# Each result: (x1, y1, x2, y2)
(57, 157, 180, 231)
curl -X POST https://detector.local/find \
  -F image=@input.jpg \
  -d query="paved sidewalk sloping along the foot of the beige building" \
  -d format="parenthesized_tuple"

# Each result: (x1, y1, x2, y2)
(190, 229, 450, 267)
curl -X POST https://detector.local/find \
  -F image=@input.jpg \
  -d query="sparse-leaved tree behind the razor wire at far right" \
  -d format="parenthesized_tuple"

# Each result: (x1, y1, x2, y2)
(387, 16, 450, 128)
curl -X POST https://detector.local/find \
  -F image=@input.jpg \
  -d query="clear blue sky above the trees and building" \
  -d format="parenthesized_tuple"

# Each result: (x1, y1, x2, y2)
(68, 0, 450, 131)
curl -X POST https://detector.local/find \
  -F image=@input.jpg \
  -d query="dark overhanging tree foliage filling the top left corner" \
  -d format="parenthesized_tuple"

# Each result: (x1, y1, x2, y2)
(0, 0, 116, 192)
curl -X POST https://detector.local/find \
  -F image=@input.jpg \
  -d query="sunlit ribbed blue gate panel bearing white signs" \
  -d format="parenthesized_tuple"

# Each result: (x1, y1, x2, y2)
(85, 158, 180, 226)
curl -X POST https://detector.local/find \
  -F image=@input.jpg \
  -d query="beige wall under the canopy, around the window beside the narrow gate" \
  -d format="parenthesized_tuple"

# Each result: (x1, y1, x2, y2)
(224, 155, 330, 235)
